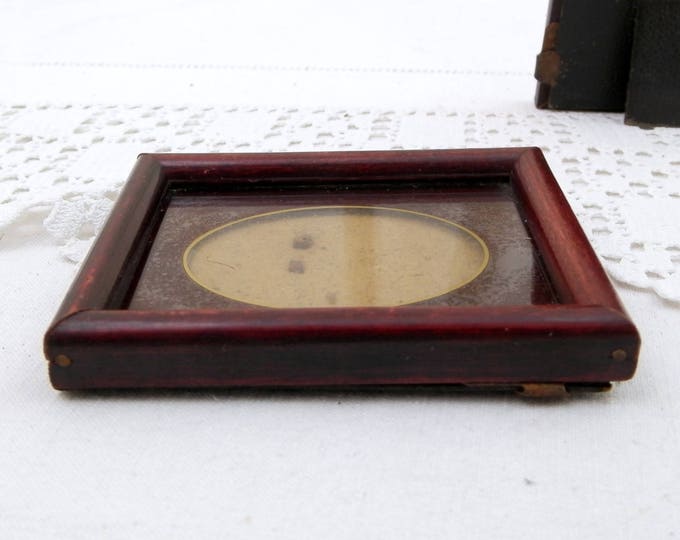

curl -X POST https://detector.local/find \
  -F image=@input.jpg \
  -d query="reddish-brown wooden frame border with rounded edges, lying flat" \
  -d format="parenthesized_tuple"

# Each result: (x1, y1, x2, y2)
(45, 148, 640, 393)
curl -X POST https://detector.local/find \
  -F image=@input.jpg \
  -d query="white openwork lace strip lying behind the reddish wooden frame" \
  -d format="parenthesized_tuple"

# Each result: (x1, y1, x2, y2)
(0, 103, 680, 302)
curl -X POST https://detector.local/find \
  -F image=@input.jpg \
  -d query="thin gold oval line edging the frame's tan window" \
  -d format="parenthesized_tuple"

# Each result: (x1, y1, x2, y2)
(182, 205, 490, 309)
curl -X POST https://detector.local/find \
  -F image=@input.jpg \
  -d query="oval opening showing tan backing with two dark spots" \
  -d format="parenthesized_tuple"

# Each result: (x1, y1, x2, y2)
(184, 206, 489, 308)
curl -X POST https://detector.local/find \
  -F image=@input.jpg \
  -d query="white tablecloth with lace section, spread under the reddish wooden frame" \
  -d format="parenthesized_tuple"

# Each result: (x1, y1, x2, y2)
(0, 0, 680, 539)
